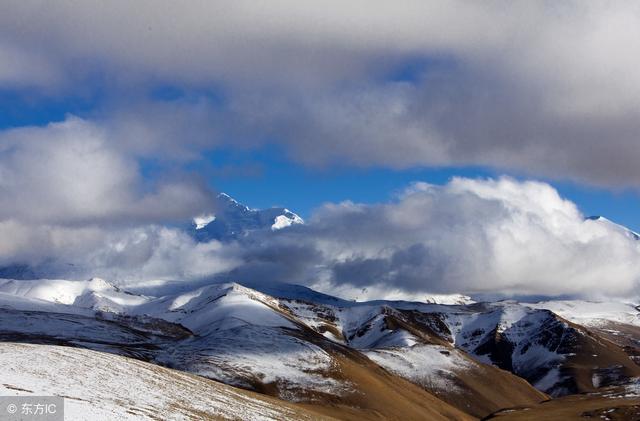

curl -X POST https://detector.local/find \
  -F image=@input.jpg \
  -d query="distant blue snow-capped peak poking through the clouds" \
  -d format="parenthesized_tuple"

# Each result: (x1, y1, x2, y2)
(189, 193, 304, 241)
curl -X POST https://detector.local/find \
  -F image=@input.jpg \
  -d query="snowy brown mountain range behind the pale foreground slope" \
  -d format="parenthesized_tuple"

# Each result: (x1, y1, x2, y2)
(0, 279, 640, 419)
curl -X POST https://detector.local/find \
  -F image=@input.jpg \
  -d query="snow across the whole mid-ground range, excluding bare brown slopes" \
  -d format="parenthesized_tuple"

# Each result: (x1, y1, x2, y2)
(0, 279, 638, 400)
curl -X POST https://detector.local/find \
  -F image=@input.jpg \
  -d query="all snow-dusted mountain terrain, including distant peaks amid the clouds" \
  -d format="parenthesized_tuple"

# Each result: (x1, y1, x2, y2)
(0, 204, 640, 420)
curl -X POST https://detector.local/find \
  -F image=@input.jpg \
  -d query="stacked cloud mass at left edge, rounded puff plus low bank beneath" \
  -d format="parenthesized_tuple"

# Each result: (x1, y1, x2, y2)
(0, 116, 234, 279)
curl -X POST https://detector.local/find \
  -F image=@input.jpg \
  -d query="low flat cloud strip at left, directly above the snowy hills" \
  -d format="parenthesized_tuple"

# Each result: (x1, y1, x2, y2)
(0, 221, 242, 284)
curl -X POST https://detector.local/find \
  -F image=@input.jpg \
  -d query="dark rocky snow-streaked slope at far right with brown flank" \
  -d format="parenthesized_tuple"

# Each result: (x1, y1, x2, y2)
(418, 302, 640, 396)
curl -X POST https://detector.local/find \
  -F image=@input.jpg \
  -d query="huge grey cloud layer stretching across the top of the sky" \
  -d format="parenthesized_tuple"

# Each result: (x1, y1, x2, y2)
(0, 0, 640, 187)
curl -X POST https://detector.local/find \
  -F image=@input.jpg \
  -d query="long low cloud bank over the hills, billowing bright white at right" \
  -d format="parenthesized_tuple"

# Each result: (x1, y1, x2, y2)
(0, 177, 640, 298)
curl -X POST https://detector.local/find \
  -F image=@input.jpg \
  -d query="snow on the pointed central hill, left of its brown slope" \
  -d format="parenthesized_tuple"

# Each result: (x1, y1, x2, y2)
(125, 283, 349, 400)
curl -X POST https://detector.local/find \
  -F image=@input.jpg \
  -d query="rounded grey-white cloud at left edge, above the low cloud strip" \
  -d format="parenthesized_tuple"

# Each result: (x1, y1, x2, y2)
(0, 117, 213, 226)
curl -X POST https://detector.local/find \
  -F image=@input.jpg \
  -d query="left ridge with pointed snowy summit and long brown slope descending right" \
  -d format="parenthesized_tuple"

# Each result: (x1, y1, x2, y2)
(0, 281, 469, 420)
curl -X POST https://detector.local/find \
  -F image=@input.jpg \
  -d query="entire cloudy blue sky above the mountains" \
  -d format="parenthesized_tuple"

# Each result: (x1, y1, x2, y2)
(0, 0, 640, 296)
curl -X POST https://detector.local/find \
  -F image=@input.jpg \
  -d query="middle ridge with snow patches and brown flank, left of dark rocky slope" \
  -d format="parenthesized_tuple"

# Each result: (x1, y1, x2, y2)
(281, 300, 547, 417)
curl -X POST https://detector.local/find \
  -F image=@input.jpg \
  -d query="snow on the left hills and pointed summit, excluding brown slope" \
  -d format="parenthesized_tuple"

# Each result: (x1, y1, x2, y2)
(0, 280, 350, 400)
